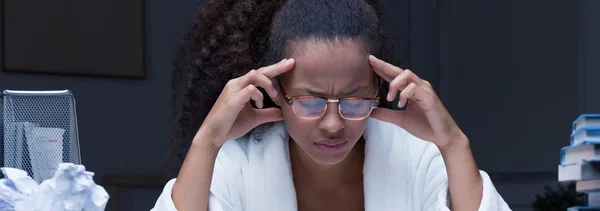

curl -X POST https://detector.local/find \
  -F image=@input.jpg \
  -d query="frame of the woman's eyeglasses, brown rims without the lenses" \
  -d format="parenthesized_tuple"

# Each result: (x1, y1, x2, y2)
(275, 77, 381, 120)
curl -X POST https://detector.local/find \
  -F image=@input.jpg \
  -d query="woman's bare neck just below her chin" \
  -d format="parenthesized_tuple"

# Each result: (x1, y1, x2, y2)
(290, 138, 364, 190)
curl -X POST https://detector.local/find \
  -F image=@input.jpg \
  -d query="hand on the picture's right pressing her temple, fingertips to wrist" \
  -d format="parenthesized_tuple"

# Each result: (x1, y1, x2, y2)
(369, 56, 466, 150)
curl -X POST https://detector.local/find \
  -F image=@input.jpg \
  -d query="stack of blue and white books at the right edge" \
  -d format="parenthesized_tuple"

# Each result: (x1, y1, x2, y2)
(558, 114, 600, 211)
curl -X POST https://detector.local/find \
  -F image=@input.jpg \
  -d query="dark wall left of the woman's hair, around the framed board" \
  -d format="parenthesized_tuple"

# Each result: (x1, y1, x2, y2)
(0, 0, 202, 210)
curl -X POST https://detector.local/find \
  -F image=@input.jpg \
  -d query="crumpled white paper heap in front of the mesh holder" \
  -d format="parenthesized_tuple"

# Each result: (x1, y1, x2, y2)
(0, 163, 109, 211)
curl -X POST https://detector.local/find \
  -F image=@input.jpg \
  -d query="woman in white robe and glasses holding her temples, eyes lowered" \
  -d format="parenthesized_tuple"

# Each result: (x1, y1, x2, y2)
(154, 0, 510, 211)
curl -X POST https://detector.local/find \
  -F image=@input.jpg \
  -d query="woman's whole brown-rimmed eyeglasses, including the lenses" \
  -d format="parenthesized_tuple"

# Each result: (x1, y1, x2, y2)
(276, 77, 379, 120)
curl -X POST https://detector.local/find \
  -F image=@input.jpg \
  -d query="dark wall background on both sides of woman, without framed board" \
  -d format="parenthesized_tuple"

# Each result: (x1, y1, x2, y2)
(0, 0, 600, 210)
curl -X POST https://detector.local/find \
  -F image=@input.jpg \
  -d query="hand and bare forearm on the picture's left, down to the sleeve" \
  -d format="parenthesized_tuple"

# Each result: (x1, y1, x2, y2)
(171, 59, 295, 210)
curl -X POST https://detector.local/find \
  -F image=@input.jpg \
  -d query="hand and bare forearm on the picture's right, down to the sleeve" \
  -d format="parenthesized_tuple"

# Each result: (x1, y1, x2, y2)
(369, 56, 483, 210)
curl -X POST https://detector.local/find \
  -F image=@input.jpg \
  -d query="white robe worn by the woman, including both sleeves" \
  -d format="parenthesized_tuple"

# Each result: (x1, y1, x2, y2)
(152, 118, 511, 211)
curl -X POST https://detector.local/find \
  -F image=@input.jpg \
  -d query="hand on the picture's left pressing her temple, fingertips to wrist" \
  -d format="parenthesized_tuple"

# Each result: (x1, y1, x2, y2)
(194, 59, 295, 149)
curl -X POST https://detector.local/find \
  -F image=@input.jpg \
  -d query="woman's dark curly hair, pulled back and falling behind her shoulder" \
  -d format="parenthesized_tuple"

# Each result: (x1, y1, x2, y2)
(166, 0, 396, 177)
